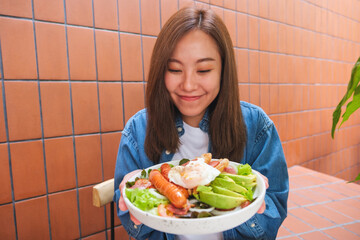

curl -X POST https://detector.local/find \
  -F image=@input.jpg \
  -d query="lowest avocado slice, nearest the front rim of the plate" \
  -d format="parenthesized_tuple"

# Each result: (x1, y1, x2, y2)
(197, 191, 246, 209)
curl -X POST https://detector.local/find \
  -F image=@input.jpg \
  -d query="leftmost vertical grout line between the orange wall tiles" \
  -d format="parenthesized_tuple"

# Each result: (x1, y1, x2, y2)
(0, 26, 19, 240)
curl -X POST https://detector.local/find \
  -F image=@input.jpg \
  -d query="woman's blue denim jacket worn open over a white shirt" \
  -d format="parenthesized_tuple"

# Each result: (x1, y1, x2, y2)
(114, 102, 289, 240)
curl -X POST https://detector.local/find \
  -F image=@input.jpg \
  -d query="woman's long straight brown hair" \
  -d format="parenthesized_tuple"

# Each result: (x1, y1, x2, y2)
(145, 7, 246, 163)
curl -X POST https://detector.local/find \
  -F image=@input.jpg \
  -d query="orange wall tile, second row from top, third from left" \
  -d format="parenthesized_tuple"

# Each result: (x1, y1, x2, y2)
(67, 27, 96, 80)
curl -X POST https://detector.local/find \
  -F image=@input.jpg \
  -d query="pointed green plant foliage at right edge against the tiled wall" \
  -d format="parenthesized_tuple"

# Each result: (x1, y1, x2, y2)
(331, 57, 360, 138)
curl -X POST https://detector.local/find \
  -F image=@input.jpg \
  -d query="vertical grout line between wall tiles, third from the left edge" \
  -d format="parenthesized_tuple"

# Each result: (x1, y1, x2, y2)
(63, 0, 82, 238)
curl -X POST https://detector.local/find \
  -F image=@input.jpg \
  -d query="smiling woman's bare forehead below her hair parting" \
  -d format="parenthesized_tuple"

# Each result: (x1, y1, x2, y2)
(171, 30, 220, 60)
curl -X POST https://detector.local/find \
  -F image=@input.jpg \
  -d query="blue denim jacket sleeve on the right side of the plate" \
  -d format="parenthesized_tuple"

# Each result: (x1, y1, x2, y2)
(231, 111, 289, 239)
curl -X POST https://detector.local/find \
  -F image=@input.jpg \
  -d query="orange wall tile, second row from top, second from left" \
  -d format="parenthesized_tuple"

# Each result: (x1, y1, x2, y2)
(35, 22, 69, 79)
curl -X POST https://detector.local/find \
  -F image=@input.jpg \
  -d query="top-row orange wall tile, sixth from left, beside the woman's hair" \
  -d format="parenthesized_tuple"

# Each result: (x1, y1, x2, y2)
(141, 0, 160, 36)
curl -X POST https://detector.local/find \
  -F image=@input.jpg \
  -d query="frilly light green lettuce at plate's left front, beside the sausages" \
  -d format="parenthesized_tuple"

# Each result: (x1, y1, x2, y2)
(125, 188, 168, 211)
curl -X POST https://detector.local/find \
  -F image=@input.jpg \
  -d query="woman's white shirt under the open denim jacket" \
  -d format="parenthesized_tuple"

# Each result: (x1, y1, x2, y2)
(173, 122, 223, 240)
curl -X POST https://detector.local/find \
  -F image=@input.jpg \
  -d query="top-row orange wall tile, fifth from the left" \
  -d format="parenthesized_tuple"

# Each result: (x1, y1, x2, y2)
(118, 0, 140, 33)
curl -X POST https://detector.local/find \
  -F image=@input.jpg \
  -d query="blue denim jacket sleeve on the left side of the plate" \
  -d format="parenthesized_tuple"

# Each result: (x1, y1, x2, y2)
(114, 130, 162, 240)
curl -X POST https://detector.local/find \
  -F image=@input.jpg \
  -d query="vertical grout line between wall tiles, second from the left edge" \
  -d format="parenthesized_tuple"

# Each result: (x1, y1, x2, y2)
(31, 0, 52, 240)
